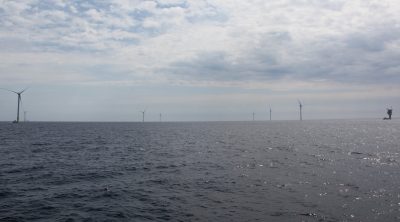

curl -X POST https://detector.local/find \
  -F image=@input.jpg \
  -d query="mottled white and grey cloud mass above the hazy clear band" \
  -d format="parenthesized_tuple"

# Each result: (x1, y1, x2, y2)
(0, 0, 400, 87)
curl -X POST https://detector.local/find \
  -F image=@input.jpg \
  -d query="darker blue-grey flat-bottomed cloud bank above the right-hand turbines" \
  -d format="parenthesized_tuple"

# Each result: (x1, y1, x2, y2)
(163, 20, 400, 84)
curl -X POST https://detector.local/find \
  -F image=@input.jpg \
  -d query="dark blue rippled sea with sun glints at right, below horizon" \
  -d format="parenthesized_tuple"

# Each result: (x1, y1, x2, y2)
(0, 120, 400, 221)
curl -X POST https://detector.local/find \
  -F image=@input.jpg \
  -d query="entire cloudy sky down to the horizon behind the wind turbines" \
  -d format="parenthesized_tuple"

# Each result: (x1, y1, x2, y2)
(0, 0, 400, 121)
